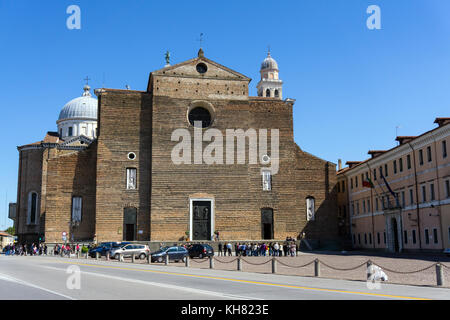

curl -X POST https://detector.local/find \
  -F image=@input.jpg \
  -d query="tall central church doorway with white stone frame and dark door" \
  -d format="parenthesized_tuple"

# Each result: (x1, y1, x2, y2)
(190, 199, 213, 240)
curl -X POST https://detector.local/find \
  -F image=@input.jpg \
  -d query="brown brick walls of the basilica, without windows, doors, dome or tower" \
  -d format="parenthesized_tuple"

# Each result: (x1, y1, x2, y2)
(14, 55, 338, 242)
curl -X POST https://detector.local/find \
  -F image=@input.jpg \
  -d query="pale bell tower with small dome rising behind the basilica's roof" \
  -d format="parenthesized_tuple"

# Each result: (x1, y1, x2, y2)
(256, 49, 283, 100)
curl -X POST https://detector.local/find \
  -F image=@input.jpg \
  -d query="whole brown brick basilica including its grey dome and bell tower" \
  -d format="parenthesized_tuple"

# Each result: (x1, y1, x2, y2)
(15, 49, 338, 243)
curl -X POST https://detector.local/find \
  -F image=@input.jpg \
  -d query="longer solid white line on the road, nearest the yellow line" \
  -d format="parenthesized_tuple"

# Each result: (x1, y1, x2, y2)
(39, 266, 264, 300)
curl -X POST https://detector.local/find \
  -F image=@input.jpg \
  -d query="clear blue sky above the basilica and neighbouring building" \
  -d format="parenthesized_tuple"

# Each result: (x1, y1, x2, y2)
(0, 0, 450, 229)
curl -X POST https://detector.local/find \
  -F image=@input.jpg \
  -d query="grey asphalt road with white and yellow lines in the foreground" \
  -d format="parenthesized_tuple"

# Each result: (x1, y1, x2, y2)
(0, 255, 450, 300)
